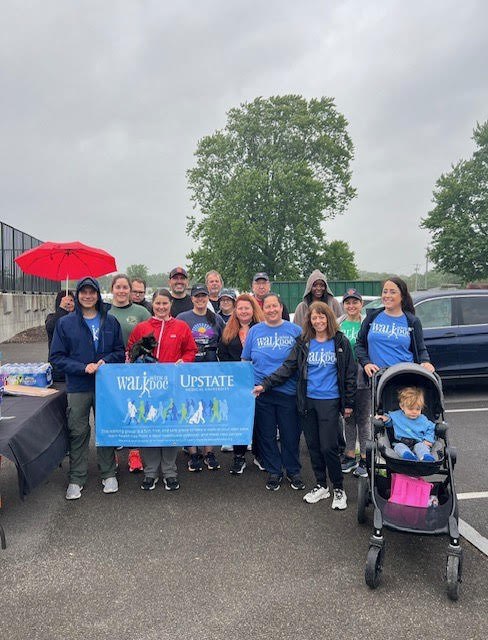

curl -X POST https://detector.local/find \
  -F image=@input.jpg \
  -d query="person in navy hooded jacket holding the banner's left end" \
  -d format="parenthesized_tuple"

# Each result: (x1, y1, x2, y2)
(50, 278, 125, 500)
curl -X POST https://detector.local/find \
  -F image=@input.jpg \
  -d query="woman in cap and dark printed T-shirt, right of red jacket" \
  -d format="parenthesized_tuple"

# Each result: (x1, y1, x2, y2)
(179, 284, 225, 471)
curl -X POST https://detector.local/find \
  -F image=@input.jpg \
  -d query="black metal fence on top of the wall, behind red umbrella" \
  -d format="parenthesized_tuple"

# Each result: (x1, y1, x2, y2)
(0, 222, 61, 293)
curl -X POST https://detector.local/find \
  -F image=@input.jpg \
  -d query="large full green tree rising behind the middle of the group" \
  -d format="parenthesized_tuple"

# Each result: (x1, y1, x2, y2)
(187, 95, 355, 288)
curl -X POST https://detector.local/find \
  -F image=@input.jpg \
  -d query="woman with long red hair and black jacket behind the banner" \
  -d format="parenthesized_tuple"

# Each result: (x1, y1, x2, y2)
(217, 289, 264, 475)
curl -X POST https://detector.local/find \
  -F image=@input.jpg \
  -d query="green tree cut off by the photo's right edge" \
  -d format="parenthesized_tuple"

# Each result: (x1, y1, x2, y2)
(422, 121, 488, 281)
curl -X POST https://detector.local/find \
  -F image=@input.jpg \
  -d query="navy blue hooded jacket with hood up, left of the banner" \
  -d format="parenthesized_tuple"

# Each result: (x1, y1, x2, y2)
(50, 278, 125, 393)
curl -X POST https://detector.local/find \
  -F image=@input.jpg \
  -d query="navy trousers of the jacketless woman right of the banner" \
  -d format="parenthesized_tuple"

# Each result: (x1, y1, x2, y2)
(255, 390, 301, 476)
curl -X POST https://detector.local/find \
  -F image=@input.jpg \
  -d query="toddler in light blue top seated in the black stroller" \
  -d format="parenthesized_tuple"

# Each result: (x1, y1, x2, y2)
(376, 387, 435, 462)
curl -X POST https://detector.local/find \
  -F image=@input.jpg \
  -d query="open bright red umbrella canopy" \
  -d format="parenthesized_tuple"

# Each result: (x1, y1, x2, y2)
(15, 242, 117, 280)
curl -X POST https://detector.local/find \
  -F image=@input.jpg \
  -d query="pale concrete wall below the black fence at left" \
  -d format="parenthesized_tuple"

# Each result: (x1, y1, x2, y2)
(0, 293, 56, 342)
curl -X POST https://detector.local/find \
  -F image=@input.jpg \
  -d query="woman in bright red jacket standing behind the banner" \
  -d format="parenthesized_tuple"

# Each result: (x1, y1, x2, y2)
(127, 289, 198, 491)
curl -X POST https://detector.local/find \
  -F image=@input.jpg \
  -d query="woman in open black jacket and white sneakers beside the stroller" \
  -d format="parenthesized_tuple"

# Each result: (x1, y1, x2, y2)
(253, 302, 357, 509)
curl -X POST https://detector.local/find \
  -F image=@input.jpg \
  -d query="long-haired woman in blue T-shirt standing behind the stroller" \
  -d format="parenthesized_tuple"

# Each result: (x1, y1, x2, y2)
(356, 277, 434, 378)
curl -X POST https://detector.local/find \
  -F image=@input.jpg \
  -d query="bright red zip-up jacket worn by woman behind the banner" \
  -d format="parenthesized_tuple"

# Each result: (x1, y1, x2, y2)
(127, 316, 198, 362)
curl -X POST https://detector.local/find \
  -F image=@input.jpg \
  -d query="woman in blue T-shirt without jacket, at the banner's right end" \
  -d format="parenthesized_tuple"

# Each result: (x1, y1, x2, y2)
(242, 293, 305, 491)
